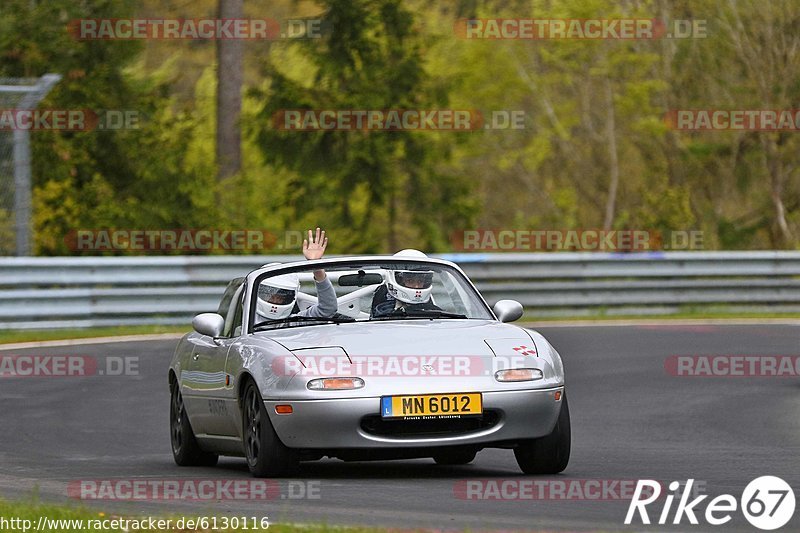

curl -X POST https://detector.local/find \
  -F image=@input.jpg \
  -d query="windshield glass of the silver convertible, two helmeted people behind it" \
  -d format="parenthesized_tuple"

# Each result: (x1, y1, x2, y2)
(250, 261, 494, 330)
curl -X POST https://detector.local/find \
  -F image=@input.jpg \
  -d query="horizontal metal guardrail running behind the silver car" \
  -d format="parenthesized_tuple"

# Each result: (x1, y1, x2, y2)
(0, 251, 800, 329)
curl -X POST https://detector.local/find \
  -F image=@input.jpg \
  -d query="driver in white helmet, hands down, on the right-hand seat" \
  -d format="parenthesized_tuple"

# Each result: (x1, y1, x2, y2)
(372, 250, 442, 318)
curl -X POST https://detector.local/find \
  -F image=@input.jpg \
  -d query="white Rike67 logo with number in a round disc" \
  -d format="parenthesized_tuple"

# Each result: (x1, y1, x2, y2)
(625, 476, 795, 531)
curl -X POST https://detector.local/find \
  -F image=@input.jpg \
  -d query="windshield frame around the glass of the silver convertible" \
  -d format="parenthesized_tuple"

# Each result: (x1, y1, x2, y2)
(242, 256, 497, 335)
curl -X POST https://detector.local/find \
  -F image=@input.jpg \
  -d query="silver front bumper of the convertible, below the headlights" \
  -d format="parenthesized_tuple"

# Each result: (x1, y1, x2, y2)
(264, 387, 564, 449)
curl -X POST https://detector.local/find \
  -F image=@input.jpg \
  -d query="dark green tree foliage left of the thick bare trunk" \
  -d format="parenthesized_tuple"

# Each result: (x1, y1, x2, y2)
(0, 0, 225, 254)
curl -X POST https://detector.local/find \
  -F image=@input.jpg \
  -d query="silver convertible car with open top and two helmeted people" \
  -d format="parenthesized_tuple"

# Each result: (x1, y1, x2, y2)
(169, 252, 570, 477)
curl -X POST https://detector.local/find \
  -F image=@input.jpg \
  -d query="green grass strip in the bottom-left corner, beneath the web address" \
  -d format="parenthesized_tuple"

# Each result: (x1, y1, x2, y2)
(0, 500, 387, 533)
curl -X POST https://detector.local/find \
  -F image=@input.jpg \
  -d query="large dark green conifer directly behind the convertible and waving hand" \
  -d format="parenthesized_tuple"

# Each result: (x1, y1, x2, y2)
(251, 0, 473, 252)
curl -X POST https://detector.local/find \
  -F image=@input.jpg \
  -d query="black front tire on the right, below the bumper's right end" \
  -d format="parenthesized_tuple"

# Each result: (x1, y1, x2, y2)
(514, 393, 572, 474)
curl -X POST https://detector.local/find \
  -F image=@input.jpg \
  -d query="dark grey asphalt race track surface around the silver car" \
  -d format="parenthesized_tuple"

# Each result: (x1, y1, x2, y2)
(0, 325, 800, 531)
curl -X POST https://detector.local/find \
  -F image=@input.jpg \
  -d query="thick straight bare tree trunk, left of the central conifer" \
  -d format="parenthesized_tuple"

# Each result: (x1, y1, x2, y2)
(217, 0, 244, 181)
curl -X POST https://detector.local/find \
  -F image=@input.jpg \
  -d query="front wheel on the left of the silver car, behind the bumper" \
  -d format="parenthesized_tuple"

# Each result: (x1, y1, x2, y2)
(242, 381, 297, 477)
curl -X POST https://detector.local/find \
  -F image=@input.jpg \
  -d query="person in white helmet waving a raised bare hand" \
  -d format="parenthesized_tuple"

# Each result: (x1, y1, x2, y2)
(256, 228, 338, 322)
